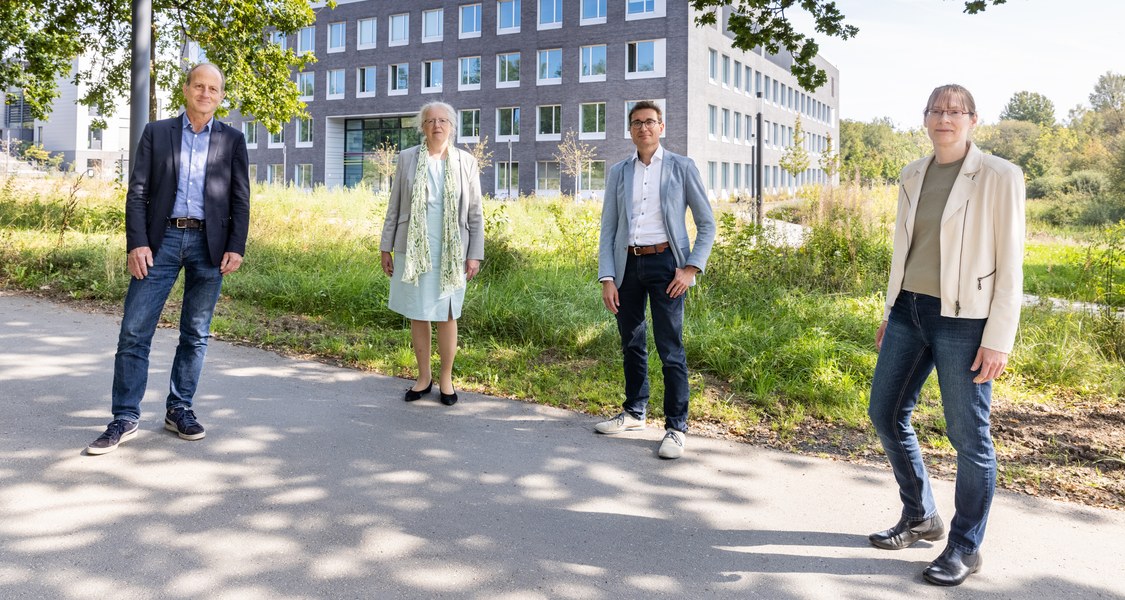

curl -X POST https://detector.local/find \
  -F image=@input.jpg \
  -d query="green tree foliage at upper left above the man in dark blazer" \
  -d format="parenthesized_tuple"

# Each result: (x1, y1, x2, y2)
(0, 0, 332, 132)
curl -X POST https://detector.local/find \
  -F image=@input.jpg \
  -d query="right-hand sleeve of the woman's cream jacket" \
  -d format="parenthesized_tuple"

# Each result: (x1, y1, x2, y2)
(981, 160, 1026, 352)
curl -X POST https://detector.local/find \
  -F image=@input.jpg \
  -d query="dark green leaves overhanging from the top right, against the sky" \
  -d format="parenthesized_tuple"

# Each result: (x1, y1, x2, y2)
(690, 0, 1006, 91)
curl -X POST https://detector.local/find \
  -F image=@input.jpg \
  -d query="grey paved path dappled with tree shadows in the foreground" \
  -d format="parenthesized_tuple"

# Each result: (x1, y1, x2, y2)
(0, 293, 1125, 600)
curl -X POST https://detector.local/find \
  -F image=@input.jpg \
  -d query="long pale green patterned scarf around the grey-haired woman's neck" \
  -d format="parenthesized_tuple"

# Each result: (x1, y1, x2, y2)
(403, 142, 465, 297)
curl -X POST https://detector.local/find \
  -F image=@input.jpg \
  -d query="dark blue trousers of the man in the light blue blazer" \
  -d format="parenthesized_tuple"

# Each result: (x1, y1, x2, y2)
(618, 250, 689, 432)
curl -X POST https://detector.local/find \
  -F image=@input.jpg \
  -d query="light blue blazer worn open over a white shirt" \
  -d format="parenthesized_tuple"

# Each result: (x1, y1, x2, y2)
(597, 150, 716, 287)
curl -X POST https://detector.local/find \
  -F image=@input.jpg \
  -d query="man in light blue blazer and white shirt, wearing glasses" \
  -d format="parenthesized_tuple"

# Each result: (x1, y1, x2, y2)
(594, 101, 716, 458)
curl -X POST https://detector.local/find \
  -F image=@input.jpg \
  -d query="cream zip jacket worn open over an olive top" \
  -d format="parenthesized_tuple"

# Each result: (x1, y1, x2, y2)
(883, 143, 1025, 352)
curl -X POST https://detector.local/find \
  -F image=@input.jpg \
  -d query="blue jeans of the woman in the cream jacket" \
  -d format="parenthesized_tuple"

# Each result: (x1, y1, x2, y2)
(867, 292, 996, 554)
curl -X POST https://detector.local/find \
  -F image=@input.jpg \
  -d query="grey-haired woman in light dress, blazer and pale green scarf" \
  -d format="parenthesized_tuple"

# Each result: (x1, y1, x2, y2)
(379, 101, 485, 405)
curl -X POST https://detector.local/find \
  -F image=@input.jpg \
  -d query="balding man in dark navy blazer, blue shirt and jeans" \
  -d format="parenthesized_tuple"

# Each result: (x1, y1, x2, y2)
(87, 63, 250, 455)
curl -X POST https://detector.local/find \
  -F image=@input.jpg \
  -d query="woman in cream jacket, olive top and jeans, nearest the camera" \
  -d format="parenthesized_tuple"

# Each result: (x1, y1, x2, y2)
(869, 84, 1025, 585)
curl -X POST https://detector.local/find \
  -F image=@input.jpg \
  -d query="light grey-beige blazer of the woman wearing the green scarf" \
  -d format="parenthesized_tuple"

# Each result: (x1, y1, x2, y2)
(379, 145, 485, 260)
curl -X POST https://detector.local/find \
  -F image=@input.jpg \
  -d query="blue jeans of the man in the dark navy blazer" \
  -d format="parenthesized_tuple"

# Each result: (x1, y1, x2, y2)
(113, 227, 223, 421)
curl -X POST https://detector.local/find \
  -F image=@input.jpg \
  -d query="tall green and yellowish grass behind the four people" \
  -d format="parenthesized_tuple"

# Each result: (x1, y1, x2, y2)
(0, 173, 1125, 432)
